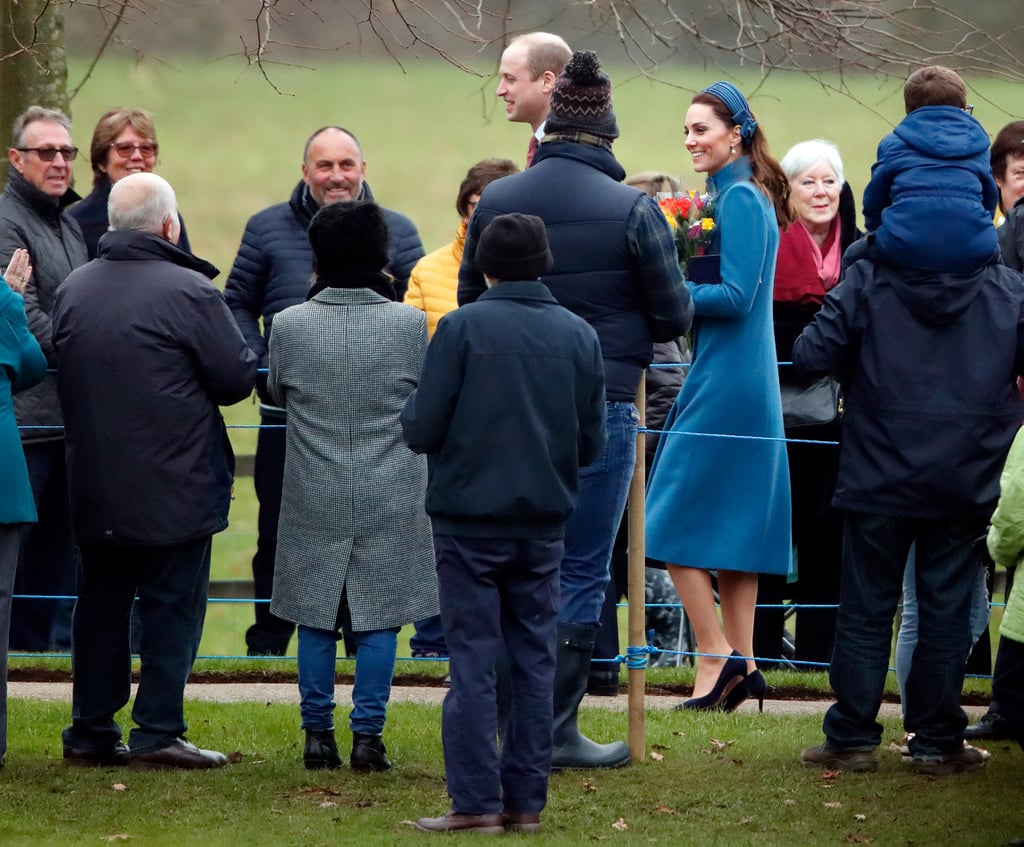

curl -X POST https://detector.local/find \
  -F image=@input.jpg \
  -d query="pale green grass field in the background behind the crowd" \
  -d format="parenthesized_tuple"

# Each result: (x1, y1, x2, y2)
(59, 57, 1019, 654)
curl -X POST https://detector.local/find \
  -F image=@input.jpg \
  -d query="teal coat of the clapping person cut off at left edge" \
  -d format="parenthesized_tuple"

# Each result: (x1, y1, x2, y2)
(0, 280, 46, 523)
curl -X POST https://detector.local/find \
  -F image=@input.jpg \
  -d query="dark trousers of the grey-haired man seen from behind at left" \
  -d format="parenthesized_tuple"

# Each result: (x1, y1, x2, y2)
(63, 536, 210, 753)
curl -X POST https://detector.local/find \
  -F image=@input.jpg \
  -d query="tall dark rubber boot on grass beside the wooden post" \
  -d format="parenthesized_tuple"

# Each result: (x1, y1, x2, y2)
(551, 622, 630, 770)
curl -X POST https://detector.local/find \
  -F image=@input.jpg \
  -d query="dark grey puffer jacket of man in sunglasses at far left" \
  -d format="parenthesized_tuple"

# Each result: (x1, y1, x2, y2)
(0, 167, 89, 441)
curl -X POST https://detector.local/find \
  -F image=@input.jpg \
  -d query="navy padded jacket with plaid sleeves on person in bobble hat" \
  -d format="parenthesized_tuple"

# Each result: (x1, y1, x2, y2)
(459, 141, 693, 401)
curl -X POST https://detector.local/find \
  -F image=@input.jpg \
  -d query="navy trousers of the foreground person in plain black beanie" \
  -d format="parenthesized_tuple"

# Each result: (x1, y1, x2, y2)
(434, 536, 563, 814)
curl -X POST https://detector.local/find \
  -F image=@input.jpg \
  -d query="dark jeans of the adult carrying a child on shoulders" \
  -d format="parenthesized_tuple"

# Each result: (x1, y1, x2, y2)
(823, 512, 985, 756)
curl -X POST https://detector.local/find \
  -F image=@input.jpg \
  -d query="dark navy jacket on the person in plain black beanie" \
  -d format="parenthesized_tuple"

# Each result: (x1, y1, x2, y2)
(401, 281, 607, 538)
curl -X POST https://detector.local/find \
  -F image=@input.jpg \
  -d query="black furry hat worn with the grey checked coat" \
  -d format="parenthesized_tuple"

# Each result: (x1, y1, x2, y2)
(309, 200, 388, 278)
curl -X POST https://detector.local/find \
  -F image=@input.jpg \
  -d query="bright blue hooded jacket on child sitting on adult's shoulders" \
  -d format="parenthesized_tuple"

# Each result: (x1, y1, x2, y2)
(863, 105, 999, 273)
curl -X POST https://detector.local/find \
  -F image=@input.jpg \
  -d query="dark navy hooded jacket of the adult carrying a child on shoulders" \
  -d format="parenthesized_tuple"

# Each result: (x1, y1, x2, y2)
(793, 251, 1024, 519)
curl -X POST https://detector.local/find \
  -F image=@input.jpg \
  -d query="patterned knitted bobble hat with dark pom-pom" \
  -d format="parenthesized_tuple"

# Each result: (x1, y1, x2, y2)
(544, 50, 618, 141)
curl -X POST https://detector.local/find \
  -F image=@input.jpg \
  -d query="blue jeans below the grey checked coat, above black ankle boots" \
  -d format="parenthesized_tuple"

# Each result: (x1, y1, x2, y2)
(298, 625, 398, 735)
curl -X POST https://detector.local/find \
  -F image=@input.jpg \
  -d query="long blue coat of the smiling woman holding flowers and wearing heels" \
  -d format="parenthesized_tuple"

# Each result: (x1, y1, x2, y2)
(646, 157, 793, 574)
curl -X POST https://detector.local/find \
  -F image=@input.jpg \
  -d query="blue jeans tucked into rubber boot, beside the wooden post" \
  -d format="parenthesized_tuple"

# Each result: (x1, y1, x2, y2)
(558, 403, 640, 625)
